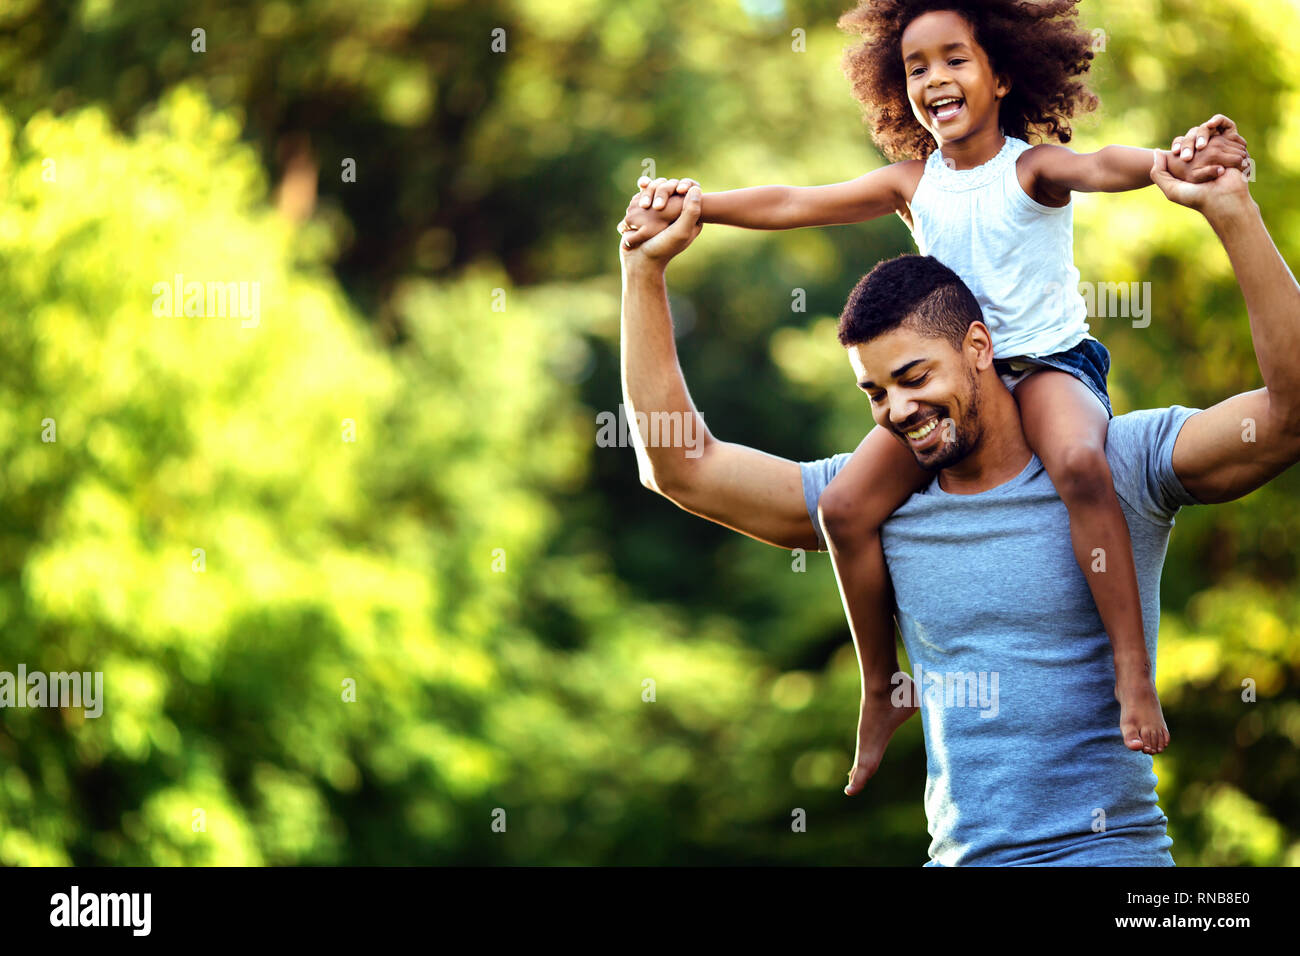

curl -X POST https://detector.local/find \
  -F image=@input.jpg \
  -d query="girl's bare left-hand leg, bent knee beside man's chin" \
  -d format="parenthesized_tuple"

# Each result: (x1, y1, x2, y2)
(818, 427, 933, 796)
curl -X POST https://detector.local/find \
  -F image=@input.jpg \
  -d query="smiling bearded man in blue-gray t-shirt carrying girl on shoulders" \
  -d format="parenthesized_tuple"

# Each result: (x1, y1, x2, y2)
(620, 152, 1300, 866)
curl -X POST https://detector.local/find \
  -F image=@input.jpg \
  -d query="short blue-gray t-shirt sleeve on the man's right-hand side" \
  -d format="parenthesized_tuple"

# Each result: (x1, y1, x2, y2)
(1106, 405, 1201, 525)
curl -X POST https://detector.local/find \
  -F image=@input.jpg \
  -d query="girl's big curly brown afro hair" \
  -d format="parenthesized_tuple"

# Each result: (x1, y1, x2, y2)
(839, 0, 1097, 161)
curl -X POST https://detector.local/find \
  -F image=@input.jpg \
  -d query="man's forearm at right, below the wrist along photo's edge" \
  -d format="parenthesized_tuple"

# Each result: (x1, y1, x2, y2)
(1208, 201, 1300, 432)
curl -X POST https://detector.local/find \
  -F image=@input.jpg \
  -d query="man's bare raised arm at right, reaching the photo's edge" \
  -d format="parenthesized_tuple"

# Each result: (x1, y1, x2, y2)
(1152, 152, 1300, 505)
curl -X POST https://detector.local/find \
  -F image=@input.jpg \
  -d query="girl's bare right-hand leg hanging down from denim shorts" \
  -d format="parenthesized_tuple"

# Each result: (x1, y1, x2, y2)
(1014, 369, 1169, 753)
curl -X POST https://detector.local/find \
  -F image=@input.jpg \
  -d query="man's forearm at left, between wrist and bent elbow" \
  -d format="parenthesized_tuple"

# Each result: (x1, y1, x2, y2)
(620, 259, 710, 492)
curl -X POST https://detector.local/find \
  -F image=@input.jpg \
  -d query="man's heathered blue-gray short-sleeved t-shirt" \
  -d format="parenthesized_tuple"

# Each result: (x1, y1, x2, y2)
(801, 406, 1200, 866)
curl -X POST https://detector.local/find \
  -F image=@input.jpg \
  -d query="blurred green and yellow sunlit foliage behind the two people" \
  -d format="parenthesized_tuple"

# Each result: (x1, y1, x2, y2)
(0, 0, 1300, 866)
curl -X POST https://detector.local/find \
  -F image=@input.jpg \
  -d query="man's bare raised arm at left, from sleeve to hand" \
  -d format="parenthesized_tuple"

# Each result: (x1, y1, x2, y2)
(619, 186, 820, 550)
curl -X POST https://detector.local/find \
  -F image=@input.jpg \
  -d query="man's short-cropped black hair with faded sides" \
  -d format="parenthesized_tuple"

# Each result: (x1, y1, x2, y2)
(840, 255, 984, 351)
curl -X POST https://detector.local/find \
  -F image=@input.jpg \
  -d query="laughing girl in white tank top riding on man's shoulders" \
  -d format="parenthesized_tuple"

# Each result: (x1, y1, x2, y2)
(620, 0, 1248, 793)
